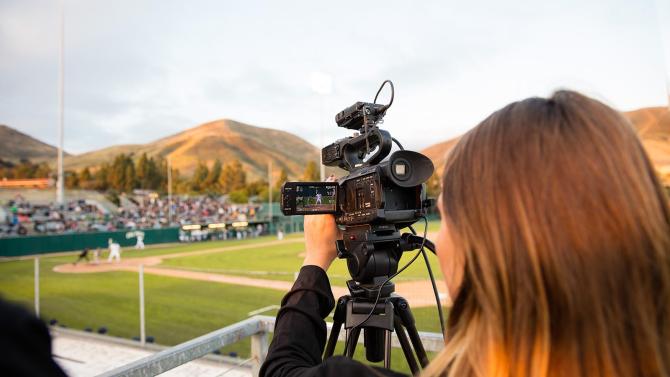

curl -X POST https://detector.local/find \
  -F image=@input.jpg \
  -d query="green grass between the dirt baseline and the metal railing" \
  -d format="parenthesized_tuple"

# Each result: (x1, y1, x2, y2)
(0, 257, 283, 355)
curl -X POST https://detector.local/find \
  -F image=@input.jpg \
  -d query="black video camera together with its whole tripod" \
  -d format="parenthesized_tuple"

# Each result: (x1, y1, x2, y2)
(281, 80, 442, 368)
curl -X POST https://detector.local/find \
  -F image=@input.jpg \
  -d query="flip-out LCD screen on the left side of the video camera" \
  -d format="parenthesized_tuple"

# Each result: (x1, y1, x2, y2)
(281, 182, 338, 215)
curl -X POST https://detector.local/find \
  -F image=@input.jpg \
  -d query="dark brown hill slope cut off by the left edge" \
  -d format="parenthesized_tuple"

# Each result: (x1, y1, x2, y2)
(0, 124, 67, 164)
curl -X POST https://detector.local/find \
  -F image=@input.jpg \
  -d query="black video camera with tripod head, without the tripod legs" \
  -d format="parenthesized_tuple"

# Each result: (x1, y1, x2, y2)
(281, 80, 434, 286)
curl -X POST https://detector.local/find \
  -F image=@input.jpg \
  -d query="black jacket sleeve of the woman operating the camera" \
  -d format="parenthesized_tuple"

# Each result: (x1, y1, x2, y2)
(260, 266, 405, 377)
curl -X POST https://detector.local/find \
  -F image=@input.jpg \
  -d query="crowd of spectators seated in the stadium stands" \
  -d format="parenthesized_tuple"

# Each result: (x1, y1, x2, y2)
(0, 193, 262, 237)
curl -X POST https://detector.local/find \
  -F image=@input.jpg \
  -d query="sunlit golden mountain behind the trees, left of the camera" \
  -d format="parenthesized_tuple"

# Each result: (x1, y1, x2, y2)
(64, 119, 319, 179)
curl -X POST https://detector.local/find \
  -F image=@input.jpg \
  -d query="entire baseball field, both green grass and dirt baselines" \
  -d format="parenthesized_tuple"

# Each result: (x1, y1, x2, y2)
(0, 223, 452, 370)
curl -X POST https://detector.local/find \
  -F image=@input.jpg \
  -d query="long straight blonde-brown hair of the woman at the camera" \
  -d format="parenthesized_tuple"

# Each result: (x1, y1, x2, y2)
(424, 91, 670, 377)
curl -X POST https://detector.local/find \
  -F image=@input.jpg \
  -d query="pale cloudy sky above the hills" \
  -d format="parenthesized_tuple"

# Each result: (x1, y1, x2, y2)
(0, 0, 670, 153)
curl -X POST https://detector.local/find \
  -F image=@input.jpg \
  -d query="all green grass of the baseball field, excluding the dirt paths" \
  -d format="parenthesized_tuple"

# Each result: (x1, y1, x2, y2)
(0, 224, 452, 371)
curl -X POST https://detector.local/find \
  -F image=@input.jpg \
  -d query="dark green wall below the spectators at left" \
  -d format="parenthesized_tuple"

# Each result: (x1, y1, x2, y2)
(0, 228, 179, 257)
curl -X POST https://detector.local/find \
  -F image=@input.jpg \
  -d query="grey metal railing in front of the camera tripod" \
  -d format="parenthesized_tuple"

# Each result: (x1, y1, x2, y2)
(99, 315, 444, 377)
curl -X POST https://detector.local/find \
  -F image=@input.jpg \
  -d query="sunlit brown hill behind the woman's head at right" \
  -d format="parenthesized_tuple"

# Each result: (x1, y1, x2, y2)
(421, 107, 670, 178)
